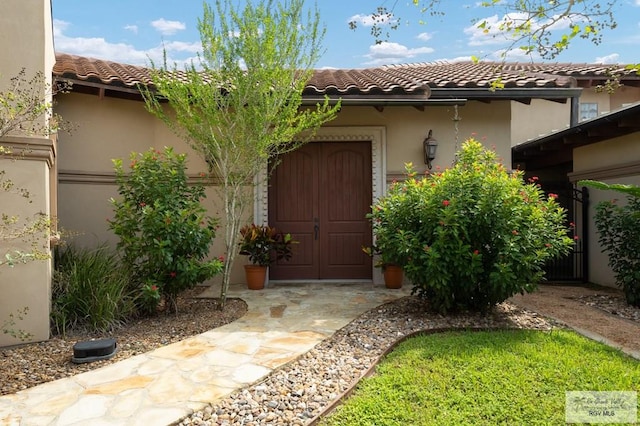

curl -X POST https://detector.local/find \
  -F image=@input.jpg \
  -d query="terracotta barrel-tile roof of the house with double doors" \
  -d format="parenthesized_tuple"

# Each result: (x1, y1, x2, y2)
(53, 53, 640, 96)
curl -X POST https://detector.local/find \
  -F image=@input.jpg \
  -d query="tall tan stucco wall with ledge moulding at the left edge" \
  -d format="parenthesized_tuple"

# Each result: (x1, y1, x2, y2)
(0, 0, 55, 346)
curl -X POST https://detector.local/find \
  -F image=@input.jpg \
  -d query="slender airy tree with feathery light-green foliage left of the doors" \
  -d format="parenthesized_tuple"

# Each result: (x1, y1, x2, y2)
(142, 0, 339, 306)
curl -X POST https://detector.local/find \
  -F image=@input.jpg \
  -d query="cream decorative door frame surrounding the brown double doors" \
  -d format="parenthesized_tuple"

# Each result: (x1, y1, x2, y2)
(253, 126, 387, 284)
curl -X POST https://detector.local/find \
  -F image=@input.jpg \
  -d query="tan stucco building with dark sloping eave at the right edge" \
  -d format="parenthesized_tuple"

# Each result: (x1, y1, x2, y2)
(513, 102, 640, 286)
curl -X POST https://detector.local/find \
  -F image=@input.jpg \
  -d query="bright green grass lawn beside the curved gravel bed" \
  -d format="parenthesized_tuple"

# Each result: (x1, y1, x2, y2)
(321, 330, 640, 426)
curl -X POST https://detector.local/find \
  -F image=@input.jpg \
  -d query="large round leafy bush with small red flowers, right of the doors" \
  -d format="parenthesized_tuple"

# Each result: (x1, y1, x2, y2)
(369, 139, 573, 312)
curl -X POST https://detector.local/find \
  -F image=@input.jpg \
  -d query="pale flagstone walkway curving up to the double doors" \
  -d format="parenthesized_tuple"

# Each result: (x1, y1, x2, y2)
(0, 283, 409, 426)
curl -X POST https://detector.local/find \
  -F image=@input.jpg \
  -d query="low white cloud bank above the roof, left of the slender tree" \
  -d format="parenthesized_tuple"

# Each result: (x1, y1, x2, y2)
(53, 20, 201, 68)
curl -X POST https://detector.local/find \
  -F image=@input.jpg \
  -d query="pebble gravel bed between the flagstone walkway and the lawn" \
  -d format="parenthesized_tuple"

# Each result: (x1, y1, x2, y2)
(179, 297, 557, 426)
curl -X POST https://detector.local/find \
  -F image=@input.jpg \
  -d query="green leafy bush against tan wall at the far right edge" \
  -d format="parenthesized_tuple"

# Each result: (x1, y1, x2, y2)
(580, 181, 640, 307)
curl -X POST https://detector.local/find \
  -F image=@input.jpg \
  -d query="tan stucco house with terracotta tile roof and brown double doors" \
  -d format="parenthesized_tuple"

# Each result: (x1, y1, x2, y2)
(53, 53, 580, 282)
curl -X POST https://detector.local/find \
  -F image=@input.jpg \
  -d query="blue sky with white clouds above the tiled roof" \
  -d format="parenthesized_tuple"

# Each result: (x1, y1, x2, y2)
(53, 0, 640, 68)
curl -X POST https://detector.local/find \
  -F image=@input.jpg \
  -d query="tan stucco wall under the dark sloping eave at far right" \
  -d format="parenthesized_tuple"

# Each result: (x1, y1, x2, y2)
(571, 133, 640, 286)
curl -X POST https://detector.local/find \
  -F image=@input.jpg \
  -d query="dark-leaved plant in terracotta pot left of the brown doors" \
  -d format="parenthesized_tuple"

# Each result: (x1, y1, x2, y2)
(240, 224, 295, 290)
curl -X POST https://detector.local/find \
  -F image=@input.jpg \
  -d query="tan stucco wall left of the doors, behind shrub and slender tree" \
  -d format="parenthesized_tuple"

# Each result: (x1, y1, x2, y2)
(56, 93, 242, 282)
